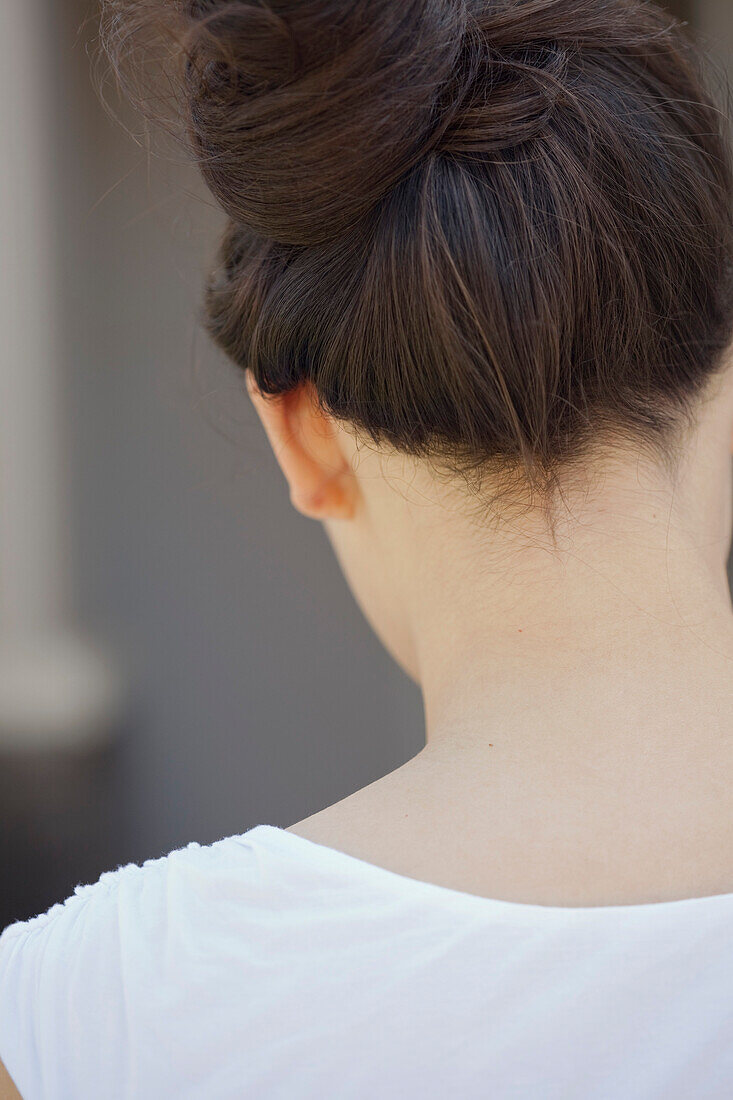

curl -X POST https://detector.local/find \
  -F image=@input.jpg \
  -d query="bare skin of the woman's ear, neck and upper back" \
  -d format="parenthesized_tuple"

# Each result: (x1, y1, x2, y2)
(249, 365, 733, 906)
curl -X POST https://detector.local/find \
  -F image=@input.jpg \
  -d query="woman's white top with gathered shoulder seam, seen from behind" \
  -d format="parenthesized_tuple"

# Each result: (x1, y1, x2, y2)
(0, 825, 733, 1100)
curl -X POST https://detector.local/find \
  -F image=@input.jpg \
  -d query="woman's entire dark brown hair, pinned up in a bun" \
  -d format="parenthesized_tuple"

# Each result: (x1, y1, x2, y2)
(102, 0, 733, 506)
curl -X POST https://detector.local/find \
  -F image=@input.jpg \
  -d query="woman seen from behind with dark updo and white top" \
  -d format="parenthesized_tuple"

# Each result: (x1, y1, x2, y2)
(0, 0, 733, 1100)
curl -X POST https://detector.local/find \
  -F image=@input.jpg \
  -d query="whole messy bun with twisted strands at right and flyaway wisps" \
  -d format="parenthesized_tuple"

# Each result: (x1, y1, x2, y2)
(102, 0, 673, 245)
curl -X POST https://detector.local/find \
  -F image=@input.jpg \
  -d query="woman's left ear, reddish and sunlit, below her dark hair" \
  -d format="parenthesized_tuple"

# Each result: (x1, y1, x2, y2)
(247, 371, 359, 519)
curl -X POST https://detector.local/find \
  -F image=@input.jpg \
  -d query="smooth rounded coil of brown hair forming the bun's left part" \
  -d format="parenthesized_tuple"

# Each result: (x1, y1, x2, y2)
(167, 0, 466, 245)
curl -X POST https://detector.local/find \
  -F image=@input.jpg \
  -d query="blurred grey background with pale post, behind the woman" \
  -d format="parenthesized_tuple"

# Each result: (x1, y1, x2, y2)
(0, 0, 733, 927)
